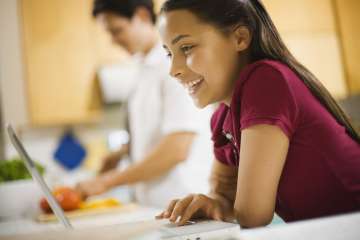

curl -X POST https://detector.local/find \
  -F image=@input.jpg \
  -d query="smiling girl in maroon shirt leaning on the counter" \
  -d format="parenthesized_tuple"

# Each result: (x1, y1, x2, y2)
(158, 0, 360, 227)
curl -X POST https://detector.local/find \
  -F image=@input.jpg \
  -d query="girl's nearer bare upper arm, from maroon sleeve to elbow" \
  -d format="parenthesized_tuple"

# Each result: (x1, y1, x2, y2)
(234, 124, 289, 227)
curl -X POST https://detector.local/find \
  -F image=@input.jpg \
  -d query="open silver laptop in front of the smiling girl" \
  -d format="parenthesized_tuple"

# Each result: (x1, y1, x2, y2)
(7, 124, 240, 240)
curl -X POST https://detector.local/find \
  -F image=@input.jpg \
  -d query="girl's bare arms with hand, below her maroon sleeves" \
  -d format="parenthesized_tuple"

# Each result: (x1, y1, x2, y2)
(157, 125, 289, 228)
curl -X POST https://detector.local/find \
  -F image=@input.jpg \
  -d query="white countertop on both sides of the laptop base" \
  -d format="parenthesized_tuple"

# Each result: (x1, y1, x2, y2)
(0, 208, 360, 240)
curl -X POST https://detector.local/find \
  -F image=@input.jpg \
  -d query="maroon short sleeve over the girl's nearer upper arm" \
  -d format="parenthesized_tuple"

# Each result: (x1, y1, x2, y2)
(240, 64, 298, 138)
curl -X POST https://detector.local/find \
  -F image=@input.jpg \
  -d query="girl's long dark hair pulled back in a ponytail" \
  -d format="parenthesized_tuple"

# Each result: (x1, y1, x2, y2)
(161, 0, 360, 143)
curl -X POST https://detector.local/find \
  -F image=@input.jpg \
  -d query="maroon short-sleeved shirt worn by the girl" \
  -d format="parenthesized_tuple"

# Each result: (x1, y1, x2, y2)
(211, 60, 360, 221)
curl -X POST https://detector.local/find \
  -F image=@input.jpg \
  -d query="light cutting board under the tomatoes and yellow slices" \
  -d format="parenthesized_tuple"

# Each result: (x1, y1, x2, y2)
(36, 203, 139, 222)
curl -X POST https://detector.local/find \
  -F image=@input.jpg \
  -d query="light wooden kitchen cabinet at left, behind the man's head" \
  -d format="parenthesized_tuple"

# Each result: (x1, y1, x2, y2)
(19, 0, 126, 126)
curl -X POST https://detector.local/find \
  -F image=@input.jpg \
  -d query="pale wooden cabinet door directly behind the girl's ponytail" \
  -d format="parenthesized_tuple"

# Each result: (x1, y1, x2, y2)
(263, 0, 348, 99)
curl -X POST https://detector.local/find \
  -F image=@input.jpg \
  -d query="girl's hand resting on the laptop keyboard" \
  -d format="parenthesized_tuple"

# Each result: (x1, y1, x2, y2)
(156, 194, 226, 226)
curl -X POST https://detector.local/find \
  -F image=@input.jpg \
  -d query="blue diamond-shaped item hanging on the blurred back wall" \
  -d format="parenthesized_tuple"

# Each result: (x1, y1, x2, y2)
(54, 130, 86, 170)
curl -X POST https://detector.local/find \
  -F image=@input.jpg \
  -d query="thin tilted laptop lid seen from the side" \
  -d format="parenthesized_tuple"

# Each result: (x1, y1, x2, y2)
(7, 124, 73, 229)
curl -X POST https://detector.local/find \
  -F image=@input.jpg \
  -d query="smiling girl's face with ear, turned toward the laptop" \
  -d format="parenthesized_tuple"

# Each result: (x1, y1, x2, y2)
(159, 10, 250, 108)
